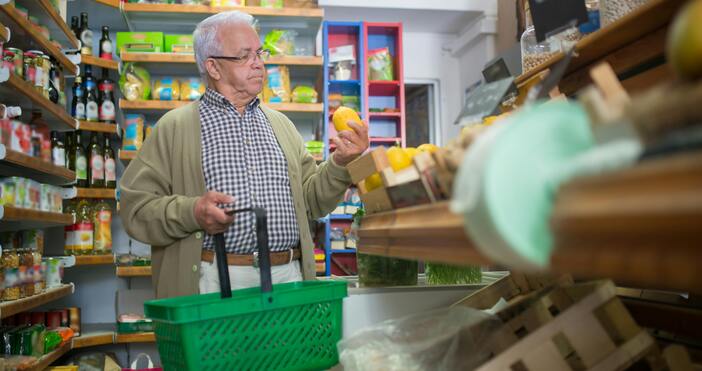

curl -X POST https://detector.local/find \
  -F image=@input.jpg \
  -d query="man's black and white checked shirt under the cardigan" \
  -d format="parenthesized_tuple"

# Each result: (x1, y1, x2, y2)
(200, 89, 300, 254)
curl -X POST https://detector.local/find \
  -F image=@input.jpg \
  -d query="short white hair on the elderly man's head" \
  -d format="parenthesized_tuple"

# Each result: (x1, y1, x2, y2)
(193, 10, 254, 80)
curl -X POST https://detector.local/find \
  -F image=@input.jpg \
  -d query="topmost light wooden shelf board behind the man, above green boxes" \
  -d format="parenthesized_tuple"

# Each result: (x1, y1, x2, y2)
(122, 2, 324, 18)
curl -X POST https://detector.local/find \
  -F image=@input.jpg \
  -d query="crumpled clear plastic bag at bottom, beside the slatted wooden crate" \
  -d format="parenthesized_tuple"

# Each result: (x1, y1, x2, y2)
(337, 307, 502, 371)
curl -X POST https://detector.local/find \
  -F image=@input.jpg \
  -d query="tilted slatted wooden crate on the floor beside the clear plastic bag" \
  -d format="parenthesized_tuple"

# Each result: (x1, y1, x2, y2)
(457, 276, 659, 370)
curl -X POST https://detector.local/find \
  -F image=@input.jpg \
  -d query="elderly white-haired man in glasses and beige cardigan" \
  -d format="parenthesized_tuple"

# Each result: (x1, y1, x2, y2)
(120, 11, 368, 298)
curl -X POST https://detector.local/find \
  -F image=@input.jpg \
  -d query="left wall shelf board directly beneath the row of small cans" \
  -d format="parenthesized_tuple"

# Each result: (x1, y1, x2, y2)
(0, 205, 73, 231)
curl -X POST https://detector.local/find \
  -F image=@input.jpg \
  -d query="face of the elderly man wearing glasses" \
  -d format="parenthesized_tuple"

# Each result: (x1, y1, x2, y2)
(215, 24, 265, 98)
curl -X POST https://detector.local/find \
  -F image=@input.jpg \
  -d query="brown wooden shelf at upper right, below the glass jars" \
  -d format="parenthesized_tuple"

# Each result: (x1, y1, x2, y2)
(515, 0, 685, 94)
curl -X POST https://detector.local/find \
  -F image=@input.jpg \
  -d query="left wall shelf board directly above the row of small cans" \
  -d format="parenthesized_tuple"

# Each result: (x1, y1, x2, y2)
(0, 144, 76, 185)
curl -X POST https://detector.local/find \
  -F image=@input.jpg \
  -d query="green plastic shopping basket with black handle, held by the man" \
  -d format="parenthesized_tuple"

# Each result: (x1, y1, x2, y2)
(144, 209, 347, 370)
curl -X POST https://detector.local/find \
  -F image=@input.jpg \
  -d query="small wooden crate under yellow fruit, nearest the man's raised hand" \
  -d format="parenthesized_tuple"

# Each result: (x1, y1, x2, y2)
(347, 147, 445, 214)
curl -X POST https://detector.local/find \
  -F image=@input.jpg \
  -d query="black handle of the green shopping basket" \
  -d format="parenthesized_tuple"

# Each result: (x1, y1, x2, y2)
(214, 208, 273, 299)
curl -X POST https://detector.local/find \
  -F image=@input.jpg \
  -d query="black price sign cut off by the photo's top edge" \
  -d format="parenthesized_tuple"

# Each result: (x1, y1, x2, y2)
(529, 0, 588, 42)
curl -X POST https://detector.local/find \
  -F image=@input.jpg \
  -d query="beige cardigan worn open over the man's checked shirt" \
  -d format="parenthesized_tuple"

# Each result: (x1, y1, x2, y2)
(119, 102, 351, 298)
